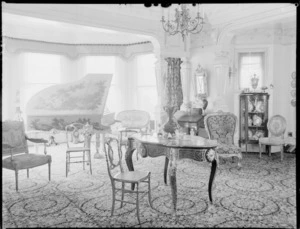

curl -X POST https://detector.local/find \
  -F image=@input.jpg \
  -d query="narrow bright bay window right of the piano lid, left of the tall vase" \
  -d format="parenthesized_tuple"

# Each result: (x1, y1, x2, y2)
(137, 54, 157, 117)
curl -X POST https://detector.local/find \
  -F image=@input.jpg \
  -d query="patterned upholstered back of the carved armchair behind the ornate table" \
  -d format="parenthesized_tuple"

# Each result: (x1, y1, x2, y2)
(204, 111, 237, 145)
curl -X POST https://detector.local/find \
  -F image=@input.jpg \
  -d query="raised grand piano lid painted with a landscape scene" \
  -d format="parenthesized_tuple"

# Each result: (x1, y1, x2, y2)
(26, 74, 112, 130)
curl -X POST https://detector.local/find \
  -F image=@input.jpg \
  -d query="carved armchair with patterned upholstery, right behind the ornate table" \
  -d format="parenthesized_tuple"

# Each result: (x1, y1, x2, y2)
(204, 111, 242, 167)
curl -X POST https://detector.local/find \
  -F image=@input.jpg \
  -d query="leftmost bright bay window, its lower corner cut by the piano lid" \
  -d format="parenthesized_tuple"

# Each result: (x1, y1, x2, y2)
(20, 53, 61, 110)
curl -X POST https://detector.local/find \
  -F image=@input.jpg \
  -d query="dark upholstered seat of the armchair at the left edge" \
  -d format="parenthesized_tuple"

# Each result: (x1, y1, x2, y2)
(2, 153, 52, 170)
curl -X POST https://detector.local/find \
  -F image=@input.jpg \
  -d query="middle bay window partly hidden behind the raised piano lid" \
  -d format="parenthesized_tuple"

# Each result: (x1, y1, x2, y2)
(85, 56, 118, 114)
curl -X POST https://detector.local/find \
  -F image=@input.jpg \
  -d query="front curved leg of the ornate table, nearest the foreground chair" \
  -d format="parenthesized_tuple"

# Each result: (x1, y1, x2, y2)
(168, 148, 178, 217)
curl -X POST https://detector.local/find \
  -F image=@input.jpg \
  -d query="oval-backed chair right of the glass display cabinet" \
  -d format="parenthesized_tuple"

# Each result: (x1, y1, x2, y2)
(258, 115, 286, 160)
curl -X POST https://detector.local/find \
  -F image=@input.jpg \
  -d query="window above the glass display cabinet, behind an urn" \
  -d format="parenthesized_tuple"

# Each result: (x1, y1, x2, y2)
(238, 52, 265, 89)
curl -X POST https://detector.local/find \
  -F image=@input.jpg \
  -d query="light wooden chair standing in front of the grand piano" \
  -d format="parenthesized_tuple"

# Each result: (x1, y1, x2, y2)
(65, 123, 93, 177)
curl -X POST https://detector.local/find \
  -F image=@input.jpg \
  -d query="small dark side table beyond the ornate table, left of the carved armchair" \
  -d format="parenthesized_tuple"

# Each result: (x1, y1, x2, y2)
(177, 114, 204, 134)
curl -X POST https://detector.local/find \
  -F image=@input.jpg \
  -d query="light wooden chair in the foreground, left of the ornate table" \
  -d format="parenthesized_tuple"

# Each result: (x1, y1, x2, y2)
(105, 137, 153, 224)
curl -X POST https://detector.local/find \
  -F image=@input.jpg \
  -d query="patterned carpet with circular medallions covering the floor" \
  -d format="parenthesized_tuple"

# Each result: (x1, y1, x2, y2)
(2, 144, 296, 228)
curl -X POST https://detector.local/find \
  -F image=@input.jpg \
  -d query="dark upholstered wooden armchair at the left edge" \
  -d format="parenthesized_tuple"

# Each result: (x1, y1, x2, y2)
(2, 121, 51, 191)
